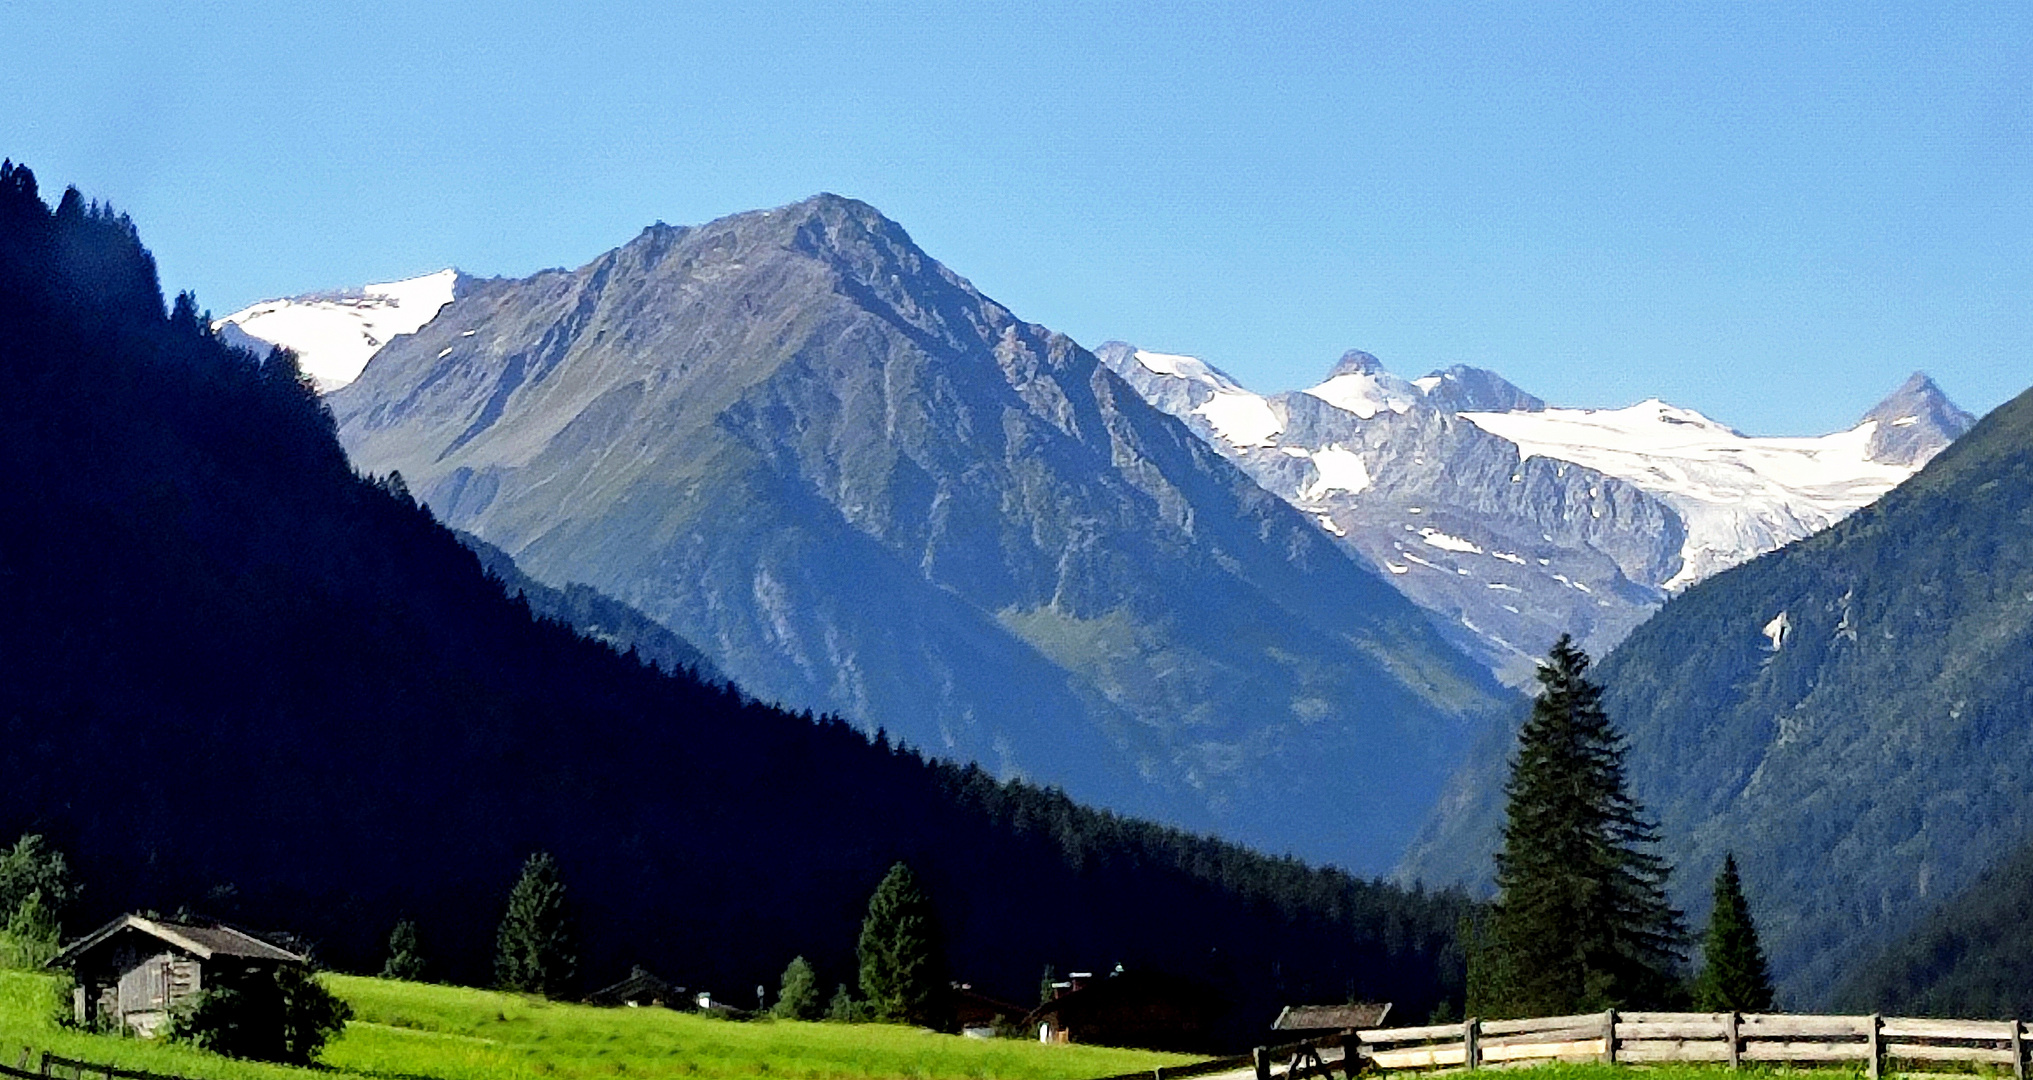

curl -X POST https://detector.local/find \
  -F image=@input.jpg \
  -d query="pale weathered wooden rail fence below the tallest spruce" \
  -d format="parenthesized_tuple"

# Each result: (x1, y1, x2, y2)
(1254, 1009, 2033, 1080)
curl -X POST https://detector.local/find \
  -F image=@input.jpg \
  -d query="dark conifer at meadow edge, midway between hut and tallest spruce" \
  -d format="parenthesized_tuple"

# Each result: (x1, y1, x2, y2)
(854, 862, 945, 1027)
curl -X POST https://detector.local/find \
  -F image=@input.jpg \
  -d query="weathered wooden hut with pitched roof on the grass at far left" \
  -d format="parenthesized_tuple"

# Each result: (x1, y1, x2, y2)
(49, 915, 307, 1037)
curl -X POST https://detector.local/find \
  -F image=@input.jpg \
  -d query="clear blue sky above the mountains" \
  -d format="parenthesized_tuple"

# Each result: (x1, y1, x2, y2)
(0, 0, 2033, 433)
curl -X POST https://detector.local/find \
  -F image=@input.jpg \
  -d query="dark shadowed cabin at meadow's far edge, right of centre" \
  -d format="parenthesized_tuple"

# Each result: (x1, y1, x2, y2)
(1025, 970, 1224, 1054)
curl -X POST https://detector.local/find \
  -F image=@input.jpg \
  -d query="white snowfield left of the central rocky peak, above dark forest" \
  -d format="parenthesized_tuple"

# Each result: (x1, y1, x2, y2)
(211, 271, 459, 393)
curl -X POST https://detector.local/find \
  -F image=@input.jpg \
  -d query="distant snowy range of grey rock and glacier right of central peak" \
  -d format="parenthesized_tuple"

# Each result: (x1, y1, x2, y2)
(1096, 342, 1972, 685)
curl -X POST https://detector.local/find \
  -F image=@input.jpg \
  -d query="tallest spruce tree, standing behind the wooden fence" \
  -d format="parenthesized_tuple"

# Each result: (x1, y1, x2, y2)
(1470, 635, 1687, 1017)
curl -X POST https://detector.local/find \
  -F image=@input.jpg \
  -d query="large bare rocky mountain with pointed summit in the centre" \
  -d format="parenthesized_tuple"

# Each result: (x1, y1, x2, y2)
(327, 195, 1504, 868)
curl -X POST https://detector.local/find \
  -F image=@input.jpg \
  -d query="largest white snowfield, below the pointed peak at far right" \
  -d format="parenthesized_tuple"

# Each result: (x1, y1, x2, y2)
(1462, 399, 1915, 590)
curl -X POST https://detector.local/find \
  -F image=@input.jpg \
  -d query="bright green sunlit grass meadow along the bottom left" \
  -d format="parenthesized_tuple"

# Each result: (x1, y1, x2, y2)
(0, 972, 1189, 1080)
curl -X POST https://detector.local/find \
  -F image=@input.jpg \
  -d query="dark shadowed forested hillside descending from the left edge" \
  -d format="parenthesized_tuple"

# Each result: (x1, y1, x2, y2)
(0, 167, 1462, 1039)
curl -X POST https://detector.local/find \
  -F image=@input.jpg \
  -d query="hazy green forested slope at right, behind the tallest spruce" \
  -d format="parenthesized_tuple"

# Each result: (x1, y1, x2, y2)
(1403, 378, 2033, 1007)
